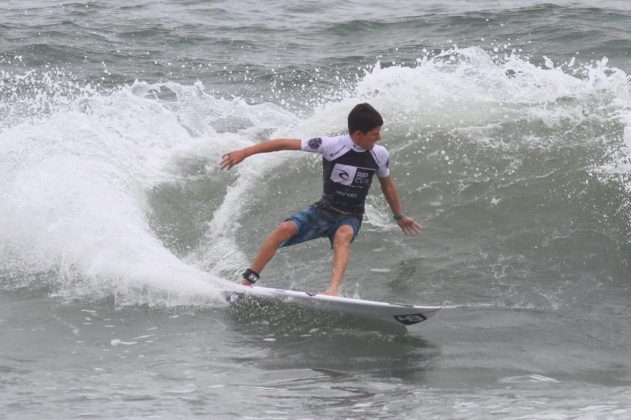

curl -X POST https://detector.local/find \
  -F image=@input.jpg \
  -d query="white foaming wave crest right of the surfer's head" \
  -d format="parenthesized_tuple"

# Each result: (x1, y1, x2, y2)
(345, 47, 629, 137)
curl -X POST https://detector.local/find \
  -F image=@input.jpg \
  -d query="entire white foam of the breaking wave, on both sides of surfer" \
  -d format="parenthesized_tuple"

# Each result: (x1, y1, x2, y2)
(0, 48, 631, 303)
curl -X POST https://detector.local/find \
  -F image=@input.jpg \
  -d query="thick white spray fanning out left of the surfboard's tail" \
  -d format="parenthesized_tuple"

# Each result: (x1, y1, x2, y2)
(0, 78, 239, 304)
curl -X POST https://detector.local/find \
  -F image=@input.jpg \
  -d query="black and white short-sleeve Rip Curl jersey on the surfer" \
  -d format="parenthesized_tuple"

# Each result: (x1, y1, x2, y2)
(301, 134, 390, 215)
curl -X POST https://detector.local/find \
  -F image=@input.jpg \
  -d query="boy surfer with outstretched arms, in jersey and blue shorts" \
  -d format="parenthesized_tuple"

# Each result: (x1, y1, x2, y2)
(220, 103, 421, 296)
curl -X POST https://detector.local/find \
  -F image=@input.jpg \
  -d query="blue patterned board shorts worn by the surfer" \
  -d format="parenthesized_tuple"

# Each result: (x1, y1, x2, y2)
(280, 204, 362, 247)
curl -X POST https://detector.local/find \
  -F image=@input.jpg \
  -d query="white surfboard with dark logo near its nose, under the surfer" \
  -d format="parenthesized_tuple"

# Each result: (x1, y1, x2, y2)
(224, 286, 441, 327)
